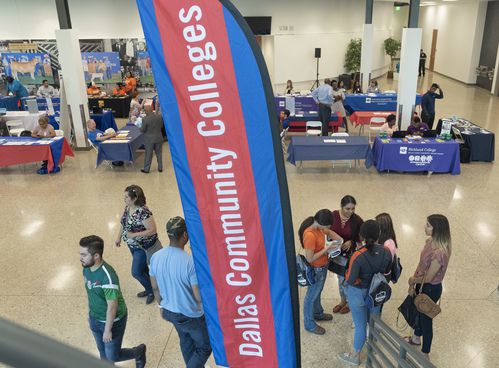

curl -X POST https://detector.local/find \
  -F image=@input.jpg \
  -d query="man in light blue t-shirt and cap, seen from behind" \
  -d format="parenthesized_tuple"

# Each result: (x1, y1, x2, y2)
(149, 216, 211, 367)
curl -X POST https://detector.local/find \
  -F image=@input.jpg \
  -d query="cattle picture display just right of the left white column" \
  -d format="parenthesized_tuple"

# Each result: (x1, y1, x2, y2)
(81, 52, 122, 83)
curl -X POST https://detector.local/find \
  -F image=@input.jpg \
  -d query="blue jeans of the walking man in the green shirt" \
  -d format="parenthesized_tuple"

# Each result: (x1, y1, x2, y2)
(88, 315, 137, 363)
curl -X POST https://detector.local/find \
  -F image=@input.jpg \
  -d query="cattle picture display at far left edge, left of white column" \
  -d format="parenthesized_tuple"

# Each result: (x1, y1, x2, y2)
(0, 52, 54, 84)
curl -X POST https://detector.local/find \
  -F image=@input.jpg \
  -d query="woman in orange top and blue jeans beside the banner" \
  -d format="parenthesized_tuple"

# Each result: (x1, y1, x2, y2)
(298, 209, 341, 335)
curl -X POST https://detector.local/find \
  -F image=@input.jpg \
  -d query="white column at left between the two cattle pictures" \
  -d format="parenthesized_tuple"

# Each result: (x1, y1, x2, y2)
(55, 29, 89, 149)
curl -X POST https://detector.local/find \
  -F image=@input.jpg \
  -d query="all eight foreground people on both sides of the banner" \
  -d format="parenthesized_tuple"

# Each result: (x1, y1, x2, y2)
(79, 185, 452, 367)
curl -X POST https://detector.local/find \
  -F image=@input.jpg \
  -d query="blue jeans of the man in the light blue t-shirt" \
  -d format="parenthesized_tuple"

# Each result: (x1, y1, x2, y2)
(161, 309, 211, 368)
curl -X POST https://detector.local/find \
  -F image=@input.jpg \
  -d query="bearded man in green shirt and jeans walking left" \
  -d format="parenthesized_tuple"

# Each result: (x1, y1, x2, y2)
(80, 235, 146, 368)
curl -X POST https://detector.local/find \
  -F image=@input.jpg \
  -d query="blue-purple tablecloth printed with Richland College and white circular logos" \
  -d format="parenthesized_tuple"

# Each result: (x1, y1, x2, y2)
(373, 137, 461, 175)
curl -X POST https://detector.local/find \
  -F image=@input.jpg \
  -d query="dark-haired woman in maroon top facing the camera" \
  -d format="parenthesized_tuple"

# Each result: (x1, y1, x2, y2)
(331, 195, 363, 314)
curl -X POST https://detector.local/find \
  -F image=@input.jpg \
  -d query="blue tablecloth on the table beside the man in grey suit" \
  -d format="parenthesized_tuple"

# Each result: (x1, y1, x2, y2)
(97, 125, 144, 166)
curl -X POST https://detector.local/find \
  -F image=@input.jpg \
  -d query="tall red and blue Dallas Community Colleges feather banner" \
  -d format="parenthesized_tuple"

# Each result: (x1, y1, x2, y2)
(137, 0, 301, 368)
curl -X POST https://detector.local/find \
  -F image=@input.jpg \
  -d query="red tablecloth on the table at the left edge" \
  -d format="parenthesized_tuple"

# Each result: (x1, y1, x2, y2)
(0, 138, 74, 172)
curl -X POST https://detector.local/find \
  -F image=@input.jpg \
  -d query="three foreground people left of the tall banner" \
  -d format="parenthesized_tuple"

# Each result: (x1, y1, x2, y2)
(79, 185, 211, 368)
